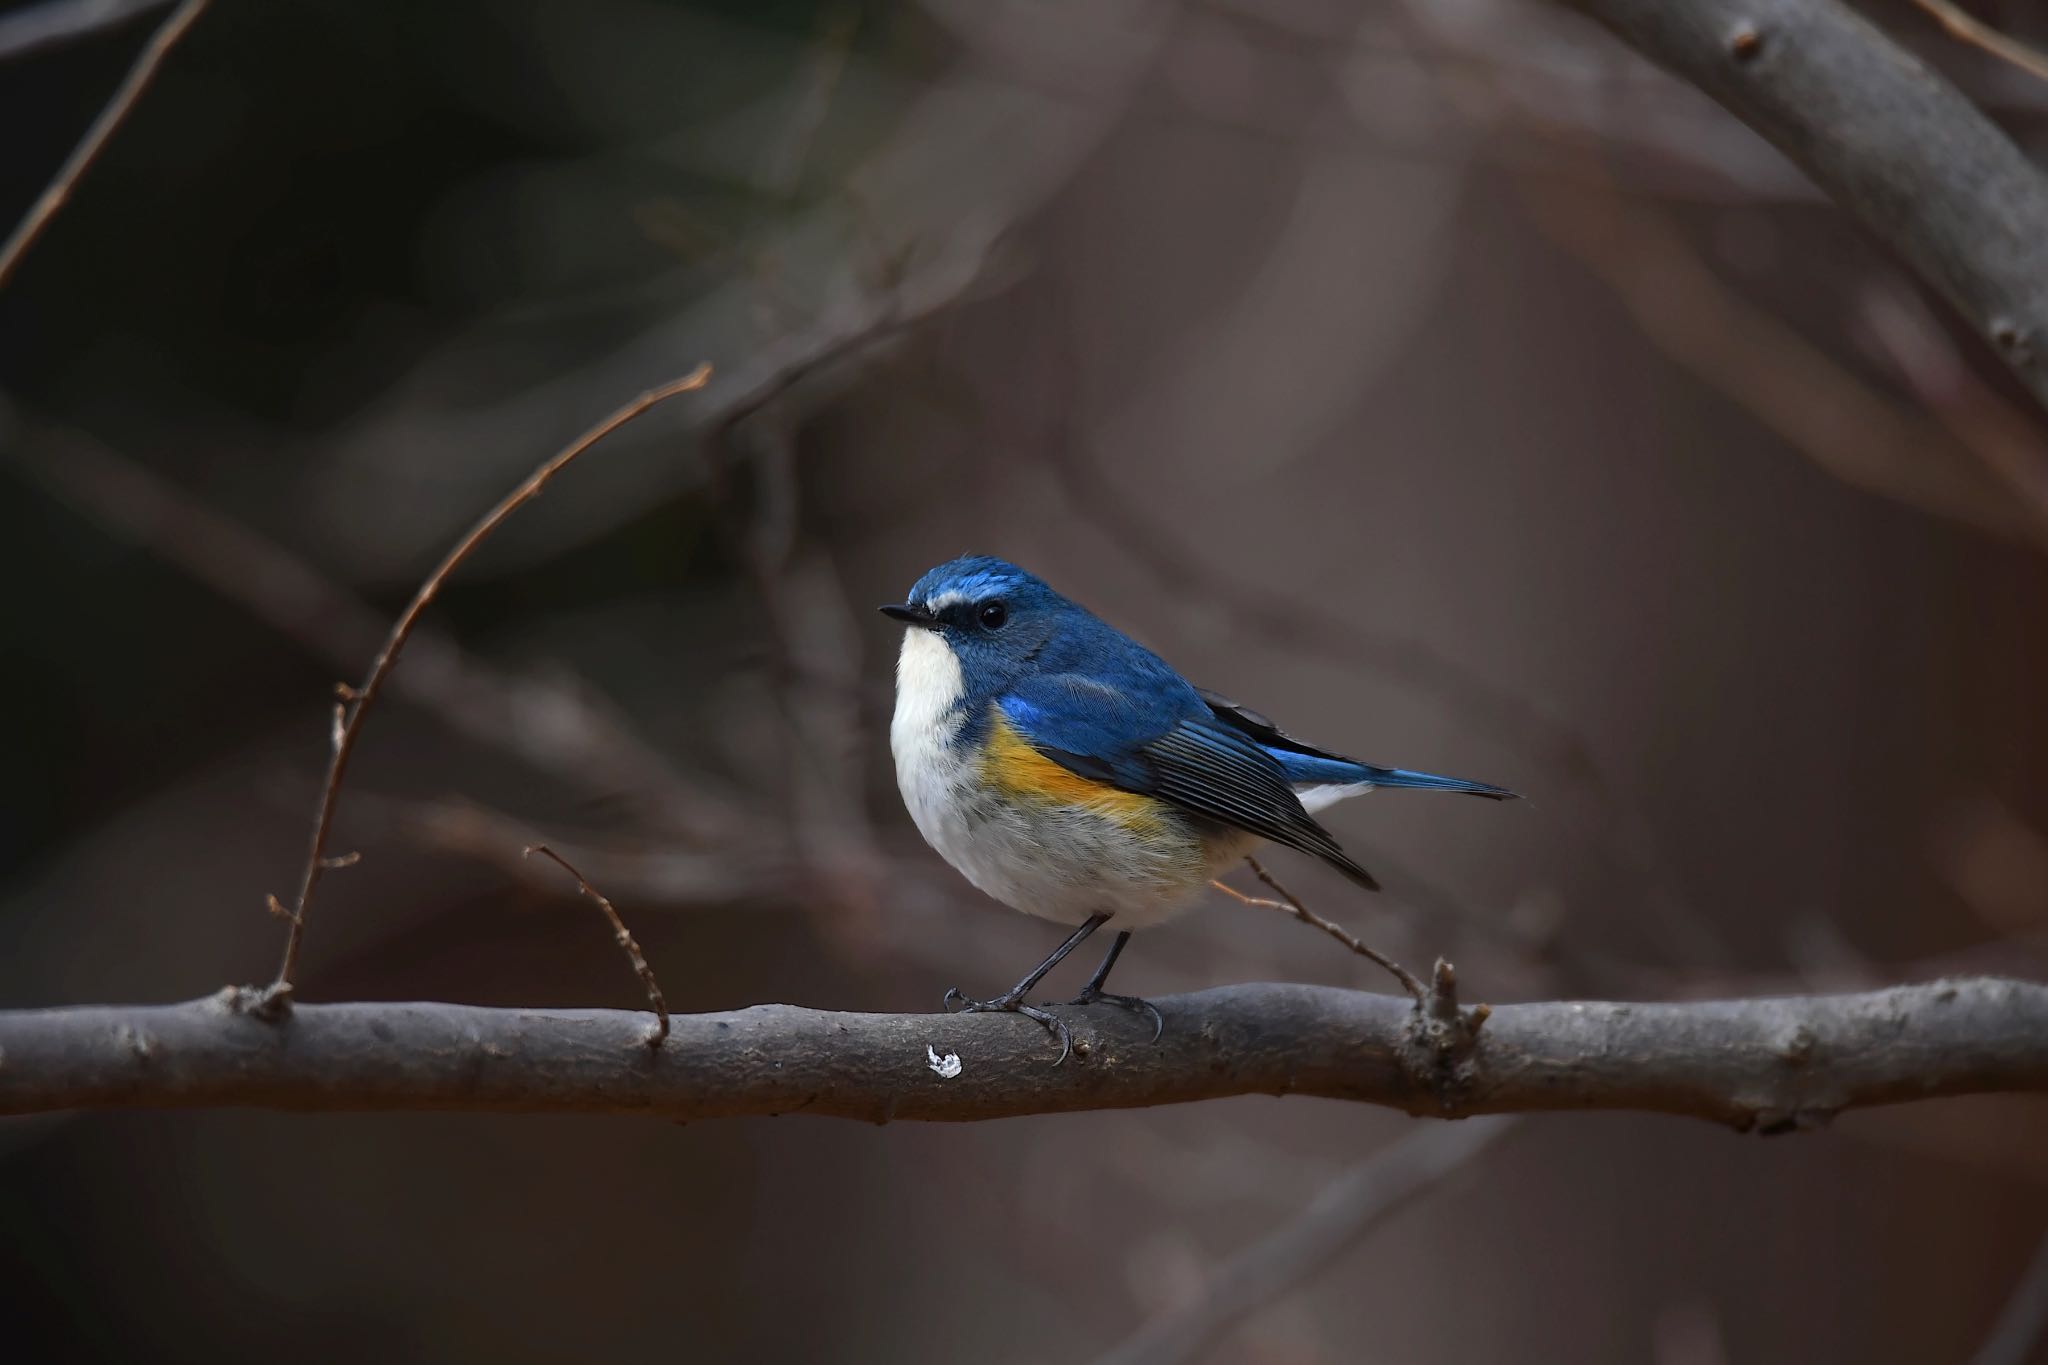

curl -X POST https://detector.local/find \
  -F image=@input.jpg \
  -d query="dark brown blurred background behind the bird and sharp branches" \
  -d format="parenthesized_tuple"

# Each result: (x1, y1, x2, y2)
(0, 0, 2048, 1365)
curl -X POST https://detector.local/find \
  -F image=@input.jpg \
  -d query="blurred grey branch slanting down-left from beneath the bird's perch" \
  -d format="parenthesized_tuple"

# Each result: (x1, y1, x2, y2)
(1096, 1117, 1520, 1365)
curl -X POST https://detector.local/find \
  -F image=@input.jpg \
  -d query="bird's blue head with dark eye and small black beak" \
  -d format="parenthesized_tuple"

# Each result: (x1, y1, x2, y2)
(883, 555, 1087, 694)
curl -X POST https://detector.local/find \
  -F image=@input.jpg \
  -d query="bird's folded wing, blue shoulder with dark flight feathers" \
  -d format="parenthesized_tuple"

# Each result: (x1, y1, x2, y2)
(997, 657, 1378, 890)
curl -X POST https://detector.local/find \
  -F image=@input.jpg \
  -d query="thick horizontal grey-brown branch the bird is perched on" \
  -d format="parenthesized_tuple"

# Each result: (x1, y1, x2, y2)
(0, 978, 2048, 1132)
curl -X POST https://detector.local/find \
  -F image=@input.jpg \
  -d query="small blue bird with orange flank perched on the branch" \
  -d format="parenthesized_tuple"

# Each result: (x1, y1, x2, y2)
(881, 555, 1513, 1060)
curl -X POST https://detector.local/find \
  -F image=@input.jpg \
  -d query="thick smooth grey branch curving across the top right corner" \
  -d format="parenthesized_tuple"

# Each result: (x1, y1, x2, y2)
(1559, 0, 2048, 407)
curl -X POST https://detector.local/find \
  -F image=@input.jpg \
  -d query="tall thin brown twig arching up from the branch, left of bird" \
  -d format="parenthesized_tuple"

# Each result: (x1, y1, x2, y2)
(266, 364, 711, 1009)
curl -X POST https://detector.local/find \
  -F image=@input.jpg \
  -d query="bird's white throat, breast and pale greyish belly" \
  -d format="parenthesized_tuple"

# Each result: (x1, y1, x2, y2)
(889, 630, 1253, 929)
